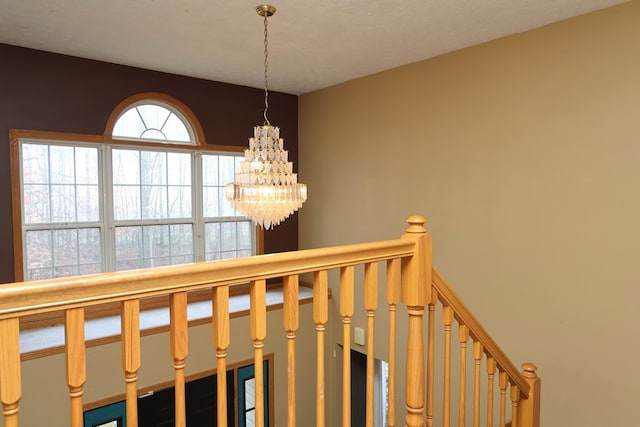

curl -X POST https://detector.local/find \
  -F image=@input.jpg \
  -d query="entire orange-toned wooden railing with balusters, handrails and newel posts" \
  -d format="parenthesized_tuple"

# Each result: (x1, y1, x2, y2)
(0, 217, 540, 427)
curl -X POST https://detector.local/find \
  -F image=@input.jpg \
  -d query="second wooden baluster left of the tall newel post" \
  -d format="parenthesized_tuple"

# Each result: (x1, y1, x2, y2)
(364, 262, 378, 427)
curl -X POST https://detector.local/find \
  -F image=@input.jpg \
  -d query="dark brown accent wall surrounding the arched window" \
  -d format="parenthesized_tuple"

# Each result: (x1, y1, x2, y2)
(0, 44, 298, 283)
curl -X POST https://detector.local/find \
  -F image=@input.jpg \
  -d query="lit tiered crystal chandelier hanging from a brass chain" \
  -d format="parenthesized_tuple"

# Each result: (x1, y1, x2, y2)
(225, 4, 307, 230)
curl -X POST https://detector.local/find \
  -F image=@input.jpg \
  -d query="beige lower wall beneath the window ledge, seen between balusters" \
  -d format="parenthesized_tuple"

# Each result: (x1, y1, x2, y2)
(9, 304, 315, 427)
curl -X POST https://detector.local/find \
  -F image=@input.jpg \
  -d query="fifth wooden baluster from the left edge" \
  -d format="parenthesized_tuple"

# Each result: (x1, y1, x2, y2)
(211, 286, 230, 426)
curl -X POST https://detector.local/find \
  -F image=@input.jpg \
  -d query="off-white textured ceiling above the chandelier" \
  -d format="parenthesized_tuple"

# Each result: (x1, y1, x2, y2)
(0, 0, 626, 94)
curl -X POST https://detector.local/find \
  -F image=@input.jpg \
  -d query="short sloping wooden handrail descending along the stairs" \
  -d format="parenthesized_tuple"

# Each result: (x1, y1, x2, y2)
(432, 268, 530, 398)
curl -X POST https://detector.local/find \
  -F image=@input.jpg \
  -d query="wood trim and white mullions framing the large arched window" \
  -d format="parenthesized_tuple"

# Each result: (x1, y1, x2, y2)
(10, 94, 256, 280)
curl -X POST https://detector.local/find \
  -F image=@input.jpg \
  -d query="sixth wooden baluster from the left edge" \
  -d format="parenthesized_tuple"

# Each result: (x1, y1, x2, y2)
(249, 280, 267, 427)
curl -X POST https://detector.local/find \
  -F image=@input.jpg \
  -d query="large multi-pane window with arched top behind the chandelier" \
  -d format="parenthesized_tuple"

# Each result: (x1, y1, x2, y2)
(12, 94, 256, 280)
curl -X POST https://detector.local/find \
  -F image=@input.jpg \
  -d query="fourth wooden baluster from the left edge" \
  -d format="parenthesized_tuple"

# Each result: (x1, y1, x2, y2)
(169, 292, 189, 427)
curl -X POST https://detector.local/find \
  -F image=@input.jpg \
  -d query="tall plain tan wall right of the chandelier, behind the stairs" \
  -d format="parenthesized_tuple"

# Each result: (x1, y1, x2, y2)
(299, 1, 640, 426)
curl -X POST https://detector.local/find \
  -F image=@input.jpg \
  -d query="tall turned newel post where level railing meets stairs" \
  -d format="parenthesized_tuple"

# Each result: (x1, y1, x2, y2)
(402, 216, 432, 427)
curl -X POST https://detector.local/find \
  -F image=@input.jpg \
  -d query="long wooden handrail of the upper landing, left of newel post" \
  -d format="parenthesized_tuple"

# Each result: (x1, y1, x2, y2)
(0, 239, 414, 319)
